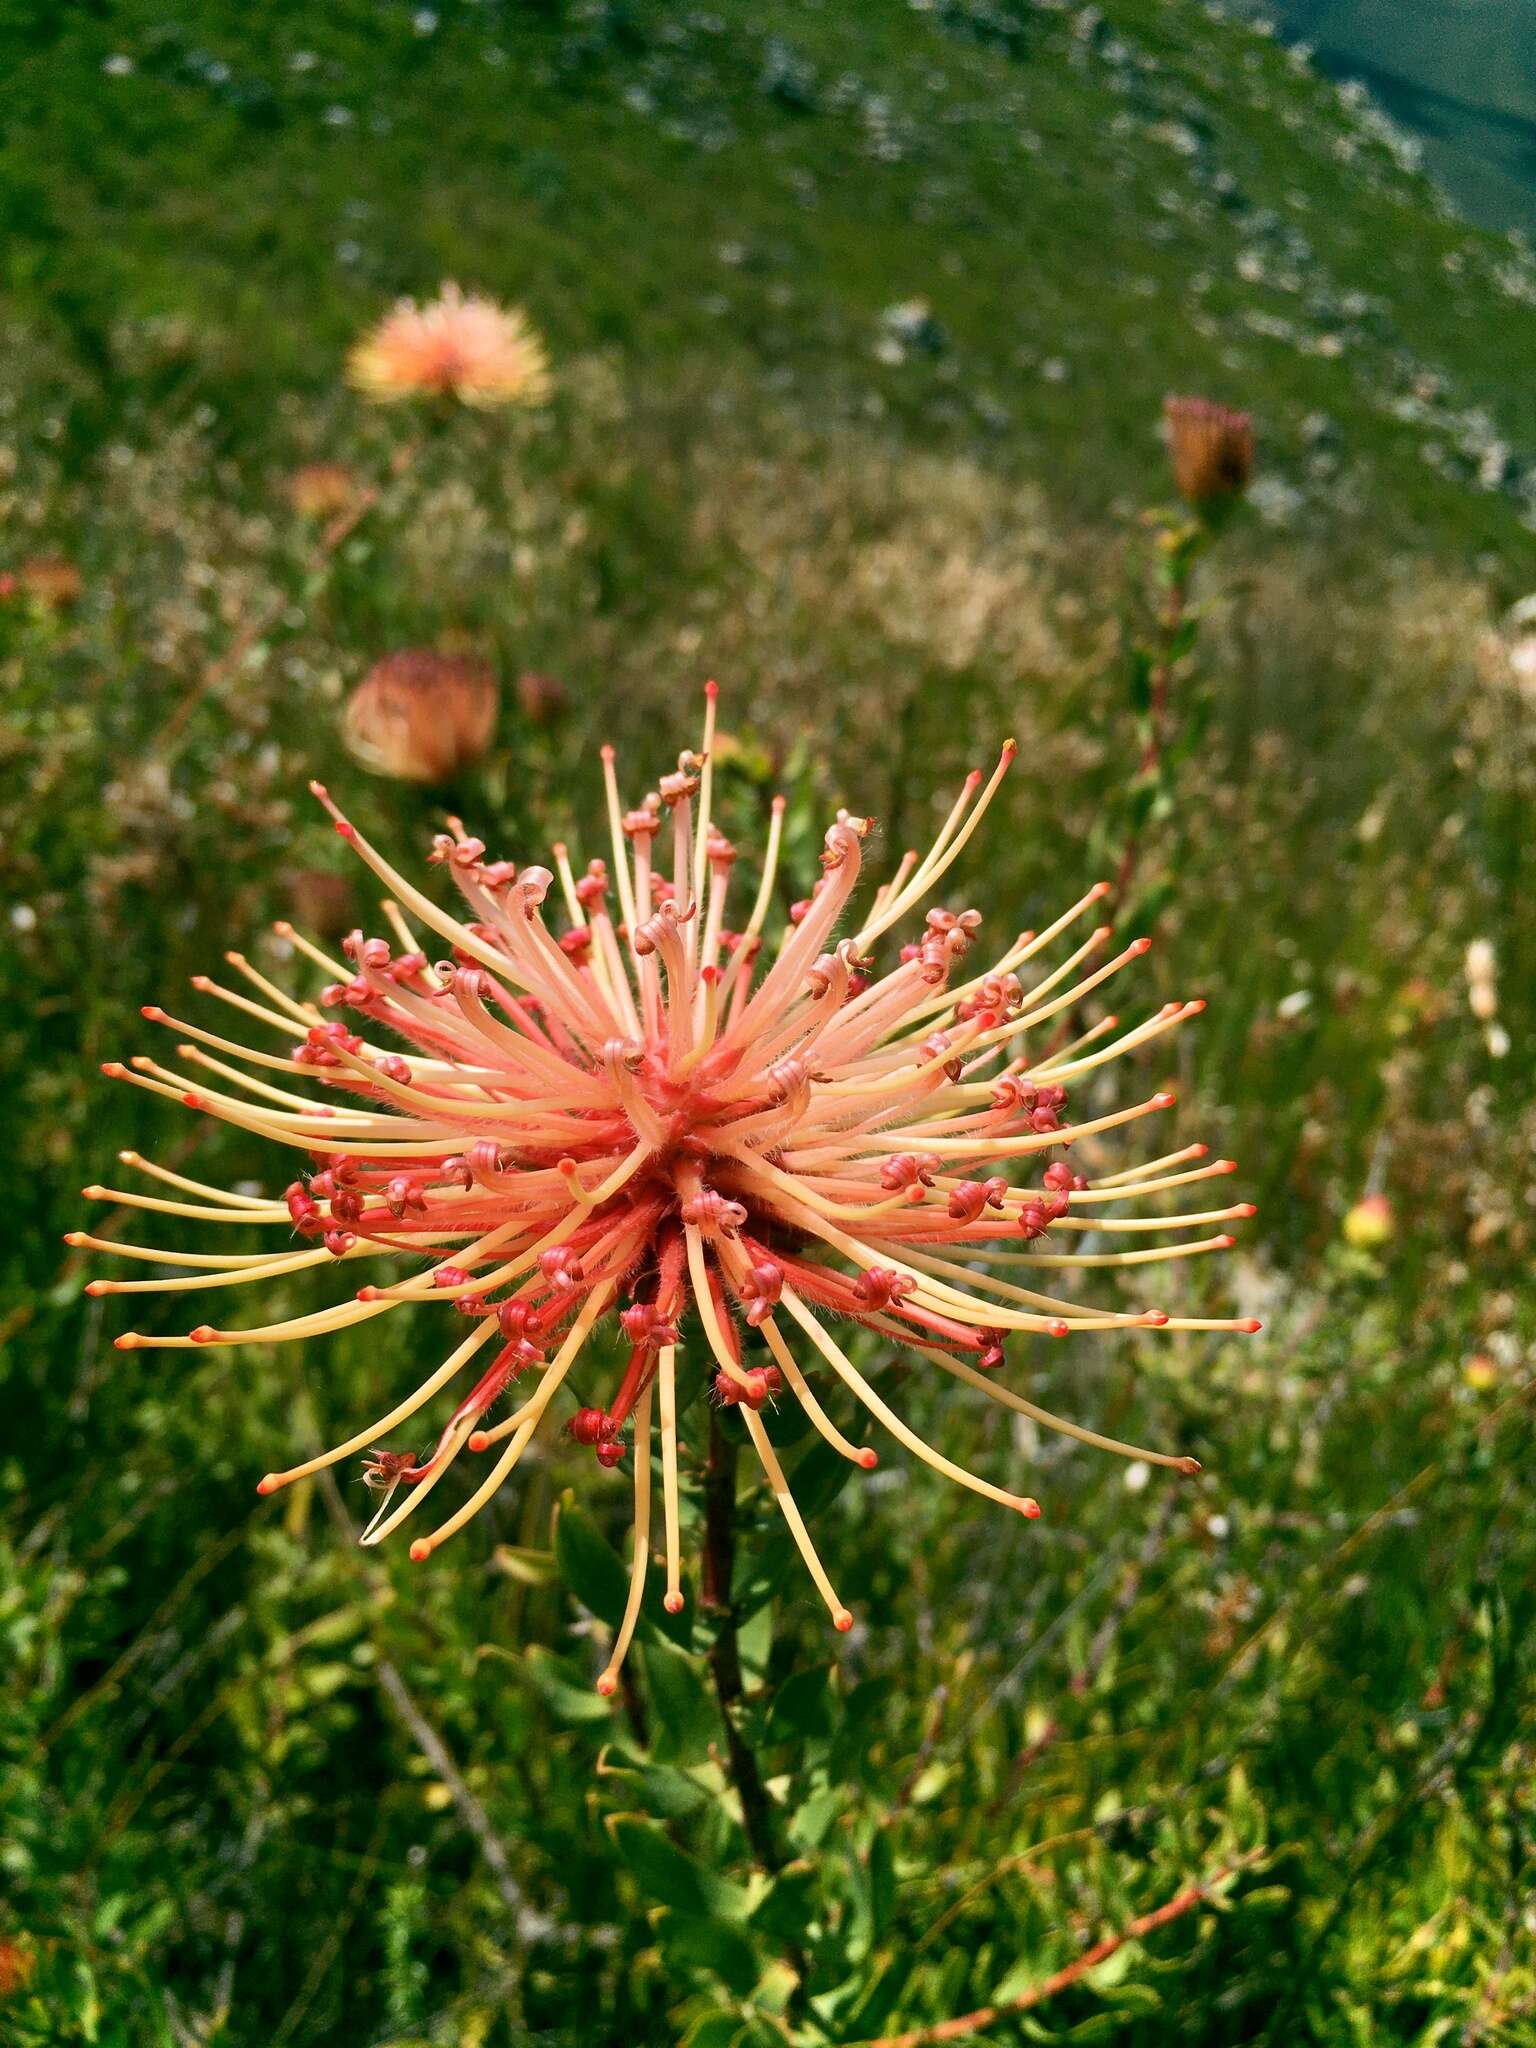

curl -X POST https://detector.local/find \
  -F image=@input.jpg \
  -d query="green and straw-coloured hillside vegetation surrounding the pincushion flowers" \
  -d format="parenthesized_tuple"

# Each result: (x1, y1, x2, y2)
(0, 0, 1536, 2048)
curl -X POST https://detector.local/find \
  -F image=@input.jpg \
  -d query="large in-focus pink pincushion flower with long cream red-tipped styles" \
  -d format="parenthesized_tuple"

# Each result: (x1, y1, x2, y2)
(72, 684, 1257, 1692)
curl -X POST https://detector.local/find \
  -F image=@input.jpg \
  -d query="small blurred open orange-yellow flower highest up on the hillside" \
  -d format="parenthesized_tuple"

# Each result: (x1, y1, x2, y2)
(346, 285, 549, 408)
